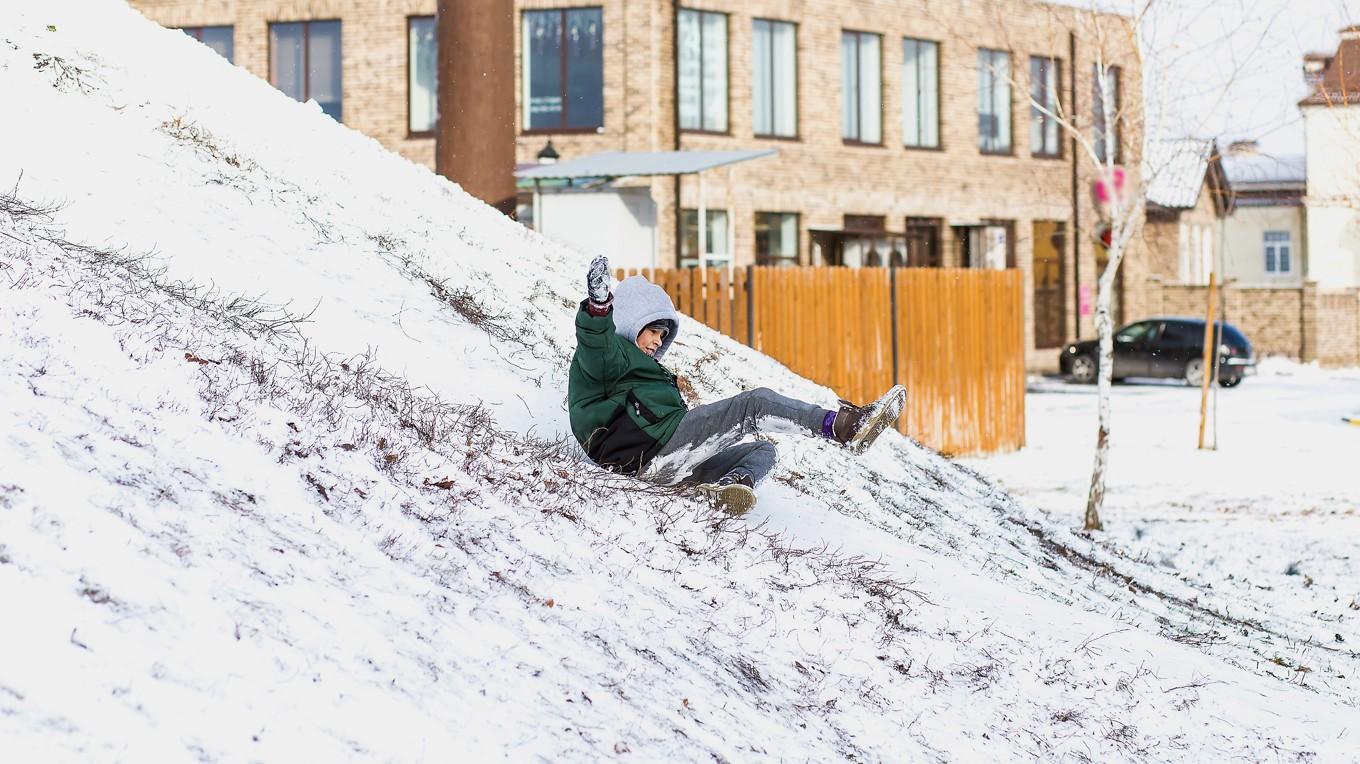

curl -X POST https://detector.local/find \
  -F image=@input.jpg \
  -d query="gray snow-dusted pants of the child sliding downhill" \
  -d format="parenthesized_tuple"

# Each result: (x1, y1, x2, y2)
(643, 387, 827, 483)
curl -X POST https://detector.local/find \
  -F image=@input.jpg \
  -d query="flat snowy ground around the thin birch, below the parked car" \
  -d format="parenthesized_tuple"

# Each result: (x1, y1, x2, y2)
(963, 359, 1360, 690)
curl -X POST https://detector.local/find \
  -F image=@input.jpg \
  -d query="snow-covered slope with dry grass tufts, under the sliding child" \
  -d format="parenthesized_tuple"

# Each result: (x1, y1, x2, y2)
(0, 0, 1360, 761)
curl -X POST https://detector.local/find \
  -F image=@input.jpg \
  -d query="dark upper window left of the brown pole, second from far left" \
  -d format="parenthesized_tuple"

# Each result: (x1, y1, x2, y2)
(269, 22, 341, 122)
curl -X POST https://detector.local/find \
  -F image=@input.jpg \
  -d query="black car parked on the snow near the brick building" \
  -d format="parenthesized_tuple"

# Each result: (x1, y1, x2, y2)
(1058, 318, 1257, 387)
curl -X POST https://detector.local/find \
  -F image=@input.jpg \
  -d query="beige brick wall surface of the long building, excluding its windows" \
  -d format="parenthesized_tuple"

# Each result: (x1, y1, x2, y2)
(132, 0, 1149, 368)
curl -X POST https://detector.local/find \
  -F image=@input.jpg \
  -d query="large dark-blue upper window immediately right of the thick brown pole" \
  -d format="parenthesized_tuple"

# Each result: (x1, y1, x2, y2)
(521, 8, 604, 131)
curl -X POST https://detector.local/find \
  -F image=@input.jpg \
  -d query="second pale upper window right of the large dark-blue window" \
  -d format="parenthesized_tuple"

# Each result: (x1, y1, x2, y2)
(751, 19, 798, 137)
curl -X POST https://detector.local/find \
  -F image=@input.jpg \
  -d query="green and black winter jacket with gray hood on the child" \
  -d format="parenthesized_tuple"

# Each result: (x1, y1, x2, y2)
(567, 276, 687, 473)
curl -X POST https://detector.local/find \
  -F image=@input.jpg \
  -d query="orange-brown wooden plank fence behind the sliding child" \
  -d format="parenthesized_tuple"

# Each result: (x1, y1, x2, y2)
(617, 266, 1024, 454)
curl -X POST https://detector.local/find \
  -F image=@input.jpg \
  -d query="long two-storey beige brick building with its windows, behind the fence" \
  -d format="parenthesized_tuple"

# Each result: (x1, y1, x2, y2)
(132, 0, 1146, 367)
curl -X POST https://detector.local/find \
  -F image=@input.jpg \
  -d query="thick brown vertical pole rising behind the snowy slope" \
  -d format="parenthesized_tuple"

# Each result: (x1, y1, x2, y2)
(434, 0, 515, 216)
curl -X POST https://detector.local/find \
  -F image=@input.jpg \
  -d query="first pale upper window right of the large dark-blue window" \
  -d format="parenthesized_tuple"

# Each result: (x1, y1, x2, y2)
(676, 8, 728, 133)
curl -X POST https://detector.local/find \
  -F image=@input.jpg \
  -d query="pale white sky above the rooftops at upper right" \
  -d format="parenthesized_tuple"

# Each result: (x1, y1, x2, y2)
(1054, 0, 1360, 154)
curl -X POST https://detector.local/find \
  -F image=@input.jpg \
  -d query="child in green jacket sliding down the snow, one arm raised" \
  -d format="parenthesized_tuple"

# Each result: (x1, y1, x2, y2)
(567, 256, 906, 514)
